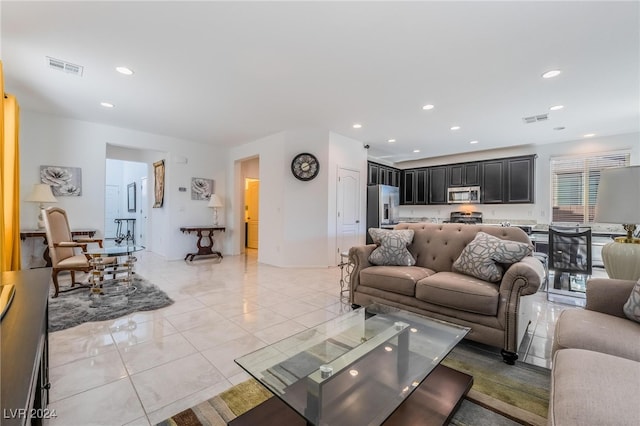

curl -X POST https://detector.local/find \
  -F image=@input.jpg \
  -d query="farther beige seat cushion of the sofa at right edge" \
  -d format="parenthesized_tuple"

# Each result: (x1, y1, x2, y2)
(553, 309, 640, 362)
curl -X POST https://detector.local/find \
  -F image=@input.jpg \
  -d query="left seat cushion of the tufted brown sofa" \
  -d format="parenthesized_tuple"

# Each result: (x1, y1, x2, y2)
(360, 266, 434, 297)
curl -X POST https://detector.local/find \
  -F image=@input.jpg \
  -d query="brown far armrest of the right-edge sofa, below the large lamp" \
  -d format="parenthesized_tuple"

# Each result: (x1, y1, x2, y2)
(585, 278, 635, 318)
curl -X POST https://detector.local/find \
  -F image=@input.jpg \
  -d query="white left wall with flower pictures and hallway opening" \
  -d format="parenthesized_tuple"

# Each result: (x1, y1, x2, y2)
(20, 110, 227, 259)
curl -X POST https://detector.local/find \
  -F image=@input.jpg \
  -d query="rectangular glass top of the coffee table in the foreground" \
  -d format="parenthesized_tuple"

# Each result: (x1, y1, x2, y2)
(236, 305, 470, 425)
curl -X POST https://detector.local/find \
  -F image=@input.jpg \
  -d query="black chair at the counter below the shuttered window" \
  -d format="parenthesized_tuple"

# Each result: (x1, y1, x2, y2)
(548, 226, 592, 293)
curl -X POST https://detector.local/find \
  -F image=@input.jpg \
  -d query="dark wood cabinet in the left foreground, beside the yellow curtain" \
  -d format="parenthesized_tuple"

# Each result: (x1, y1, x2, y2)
(0, 268, 50, 426)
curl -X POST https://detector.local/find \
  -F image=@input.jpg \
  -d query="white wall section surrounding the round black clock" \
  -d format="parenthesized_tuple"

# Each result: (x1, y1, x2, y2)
(226, 129, 366, 267)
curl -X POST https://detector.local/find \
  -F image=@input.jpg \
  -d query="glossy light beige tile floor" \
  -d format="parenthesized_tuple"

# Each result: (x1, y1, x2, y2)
(42, 251, 604, 426)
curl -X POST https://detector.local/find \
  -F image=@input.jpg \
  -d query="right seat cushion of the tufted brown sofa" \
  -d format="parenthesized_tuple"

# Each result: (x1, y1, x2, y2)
(416, 272, 500, 315)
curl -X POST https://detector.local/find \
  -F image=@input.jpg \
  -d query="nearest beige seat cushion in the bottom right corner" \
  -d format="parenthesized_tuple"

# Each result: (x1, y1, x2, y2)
(548, 349, 640, 426)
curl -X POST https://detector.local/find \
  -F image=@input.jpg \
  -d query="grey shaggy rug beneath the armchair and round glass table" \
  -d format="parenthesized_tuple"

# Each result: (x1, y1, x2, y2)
(49, 275, 173, 332)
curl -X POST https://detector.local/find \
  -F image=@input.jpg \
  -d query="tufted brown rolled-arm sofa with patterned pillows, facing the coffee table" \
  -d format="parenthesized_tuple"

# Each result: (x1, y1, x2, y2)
(349, 223, 545, 364)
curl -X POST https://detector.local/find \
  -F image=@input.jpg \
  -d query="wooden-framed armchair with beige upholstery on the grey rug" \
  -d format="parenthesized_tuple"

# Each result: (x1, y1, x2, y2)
(43, 207, 117, 297)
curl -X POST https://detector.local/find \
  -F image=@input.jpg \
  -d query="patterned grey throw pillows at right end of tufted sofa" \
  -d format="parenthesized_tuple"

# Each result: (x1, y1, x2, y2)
(453, 232, 531, 282)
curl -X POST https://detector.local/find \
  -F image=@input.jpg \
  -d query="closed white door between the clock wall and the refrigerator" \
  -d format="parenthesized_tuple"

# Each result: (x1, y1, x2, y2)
(336, 168, 360, 264)
